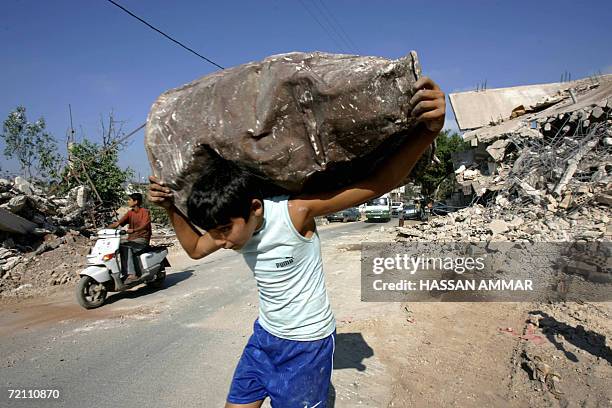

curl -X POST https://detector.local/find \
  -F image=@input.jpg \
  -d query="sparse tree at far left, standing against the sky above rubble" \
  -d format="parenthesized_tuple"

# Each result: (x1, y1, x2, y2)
(0, 106, 61, 179)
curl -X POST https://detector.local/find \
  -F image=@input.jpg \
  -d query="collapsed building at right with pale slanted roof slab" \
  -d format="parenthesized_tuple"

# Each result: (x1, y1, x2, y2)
(450, 75, 612, 212)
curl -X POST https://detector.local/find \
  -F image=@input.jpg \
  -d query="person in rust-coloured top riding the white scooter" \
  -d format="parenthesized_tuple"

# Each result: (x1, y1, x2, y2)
(108, 193, 151, 283)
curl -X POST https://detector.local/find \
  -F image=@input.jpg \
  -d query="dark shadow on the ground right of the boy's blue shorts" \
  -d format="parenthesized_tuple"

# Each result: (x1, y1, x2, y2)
(327, 333, 374, 408)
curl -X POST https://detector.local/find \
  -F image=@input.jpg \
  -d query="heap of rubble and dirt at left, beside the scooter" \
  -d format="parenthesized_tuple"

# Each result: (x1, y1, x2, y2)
(0, 177, 103, 296)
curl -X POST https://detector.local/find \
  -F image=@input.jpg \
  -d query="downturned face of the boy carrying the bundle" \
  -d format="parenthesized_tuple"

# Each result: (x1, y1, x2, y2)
(208, 200, 263, 250)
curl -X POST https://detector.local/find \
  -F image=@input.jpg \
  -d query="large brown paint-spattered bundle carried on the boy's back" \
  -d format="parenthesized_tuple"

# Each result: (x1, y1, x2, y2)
(145, 51, 430, 214)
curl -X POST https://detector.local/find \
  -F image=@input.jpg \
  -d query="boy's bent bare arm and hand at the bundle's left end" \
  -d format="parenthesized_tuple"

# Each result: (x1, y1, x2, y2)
(149, 176, 221, 259)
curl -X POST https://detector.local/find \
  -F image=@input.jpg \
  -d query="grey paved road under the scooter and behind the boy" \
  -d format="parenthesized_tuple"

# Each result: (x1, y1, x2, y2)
(0, 219, 397, 408)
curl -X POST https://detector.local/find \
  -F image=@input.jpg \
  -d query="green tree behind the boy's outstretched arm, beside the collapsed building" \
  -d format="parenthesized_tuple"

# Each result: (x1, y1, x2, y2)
(414, 130, 469, 198)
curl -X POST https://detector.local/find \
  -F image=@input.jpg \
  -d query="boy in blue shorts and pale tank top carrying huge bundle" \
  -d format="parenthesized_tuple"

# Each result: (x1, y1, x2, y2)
(149, 77, 445, 408)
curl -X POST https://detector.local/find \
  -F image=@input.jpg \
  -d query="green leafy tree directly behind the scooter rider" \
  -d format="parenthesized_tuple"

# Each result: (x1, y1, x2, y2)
(61, 139, 134, 207)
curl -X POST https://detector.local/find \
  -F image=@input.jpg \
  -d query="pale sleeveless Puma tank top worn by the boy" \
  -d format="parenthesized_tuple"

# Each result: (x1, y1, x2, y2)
(238, 196, 336, 341)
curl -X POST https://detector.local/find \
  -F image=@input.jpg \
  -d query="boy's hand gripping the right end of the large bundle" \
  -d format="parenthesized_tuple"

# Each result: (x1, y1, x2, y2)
(410, 77, 446, 134)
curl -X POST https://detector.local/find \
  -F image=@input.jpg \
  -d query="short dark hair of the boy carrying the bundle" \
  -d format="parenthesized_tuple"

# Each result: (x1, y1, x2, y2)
(187, 156, 265, 230)
